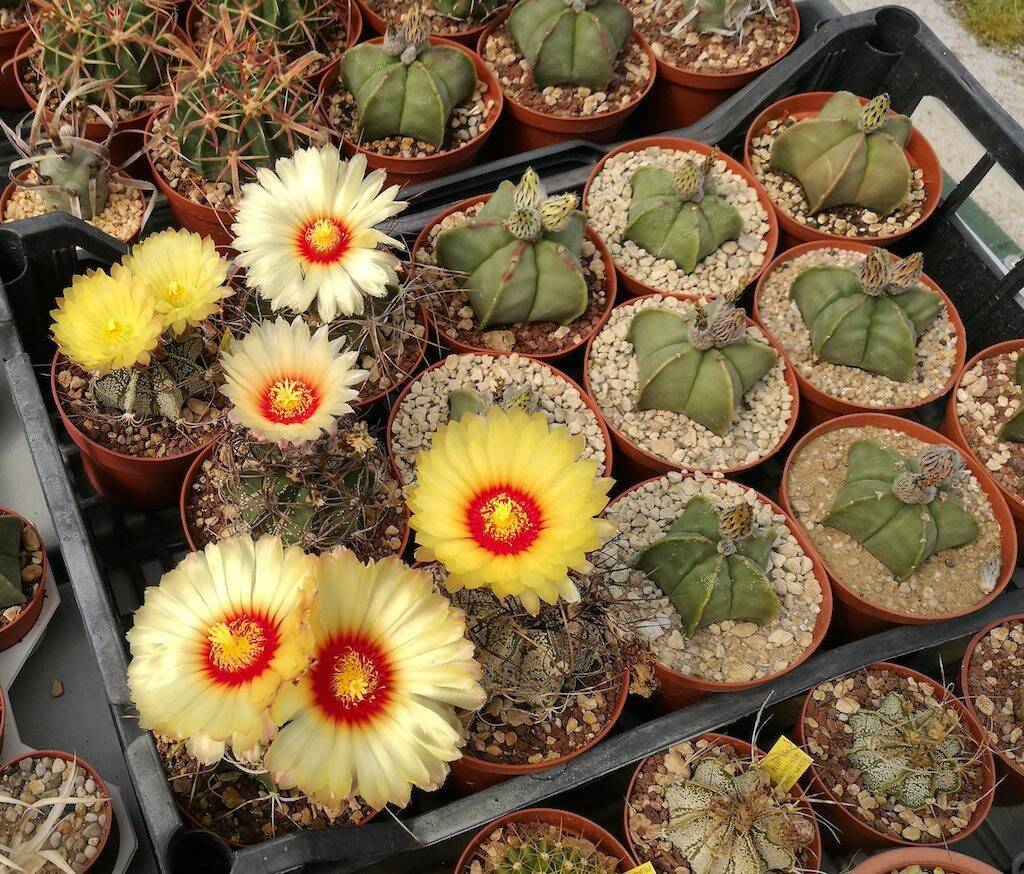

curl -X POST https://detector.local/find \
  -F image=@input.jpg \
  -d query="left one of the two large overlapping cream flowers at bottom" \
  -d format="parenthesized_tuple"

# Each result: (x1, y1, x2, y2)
(128, 535, 317, 763)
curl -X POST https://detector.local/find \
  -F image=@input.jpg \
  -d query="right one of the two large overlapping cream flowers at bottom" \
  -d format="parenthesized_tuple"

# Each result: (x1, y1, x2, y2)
(265, 550, 484, 810)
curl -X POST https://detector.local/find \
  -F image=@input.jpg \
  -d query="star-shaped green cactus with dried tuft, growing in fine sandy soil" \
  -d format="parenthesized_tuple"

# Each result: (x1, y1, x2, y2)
(822, 440, 980, 579)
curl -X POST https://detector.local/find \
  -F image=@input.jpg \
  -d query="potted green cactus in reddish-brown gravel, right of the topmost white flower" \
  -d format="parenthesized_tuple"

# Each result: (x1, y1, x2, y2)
(413, 168, 615, 359)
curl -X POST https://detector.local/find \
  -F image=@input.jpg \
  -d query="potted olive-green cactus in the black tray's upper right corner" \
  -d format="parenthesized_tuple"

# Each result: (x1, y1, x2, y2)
(743, 91, 942, 246)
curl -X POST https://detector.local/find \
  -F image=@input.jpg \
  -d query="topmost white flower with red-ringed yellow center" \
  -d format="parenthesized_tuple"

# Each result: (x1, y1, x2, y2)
(232, 145, 406, 321)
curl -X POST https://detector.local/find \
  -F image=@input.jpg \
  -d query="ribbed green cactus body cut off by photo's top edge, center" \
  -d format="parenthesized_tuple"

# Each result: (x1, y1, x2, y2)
(508, 0, 633, 91)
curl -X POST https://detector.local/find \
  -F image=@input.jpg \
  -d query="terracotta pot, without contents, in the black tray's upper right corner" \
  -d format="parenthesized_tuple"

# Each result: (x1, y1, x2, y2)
(743, 91, 942, 249)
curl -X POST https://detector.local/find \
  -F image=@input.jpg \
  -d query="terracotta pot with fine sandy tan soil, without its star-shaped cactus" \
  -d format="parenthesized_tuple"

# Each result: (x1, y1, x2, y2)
(779, 412, 1017, 640)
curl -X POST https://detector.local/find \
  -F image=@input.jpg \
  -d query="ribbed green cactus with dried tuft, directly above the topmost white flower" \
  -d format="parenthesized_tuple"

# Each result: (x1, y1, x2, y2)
(341, 6, 476, 147)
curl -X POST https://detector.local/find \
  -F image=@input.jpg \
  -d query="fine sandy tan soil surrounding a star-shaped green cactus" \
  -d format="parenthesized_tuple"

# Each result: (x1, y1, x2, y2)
(786, 427, 1000, 616)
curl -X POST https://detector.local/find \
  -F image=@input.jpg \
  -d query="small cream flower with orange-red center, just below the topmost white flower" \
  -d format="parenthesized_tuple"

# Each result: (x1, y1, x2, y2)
(220, 317, 368, 443)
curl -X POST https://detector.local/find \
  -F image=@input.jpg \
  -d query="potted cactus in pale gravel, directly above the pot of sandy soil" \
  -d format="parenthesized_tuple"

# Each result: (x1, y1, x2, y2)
(754, 242, 967, 424)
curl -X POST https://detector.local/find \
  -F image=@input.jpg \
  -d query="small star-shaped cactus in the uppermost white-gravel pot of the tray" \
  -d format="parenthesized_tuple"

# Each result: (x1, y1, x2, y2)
(624, 149, 743, 273)
